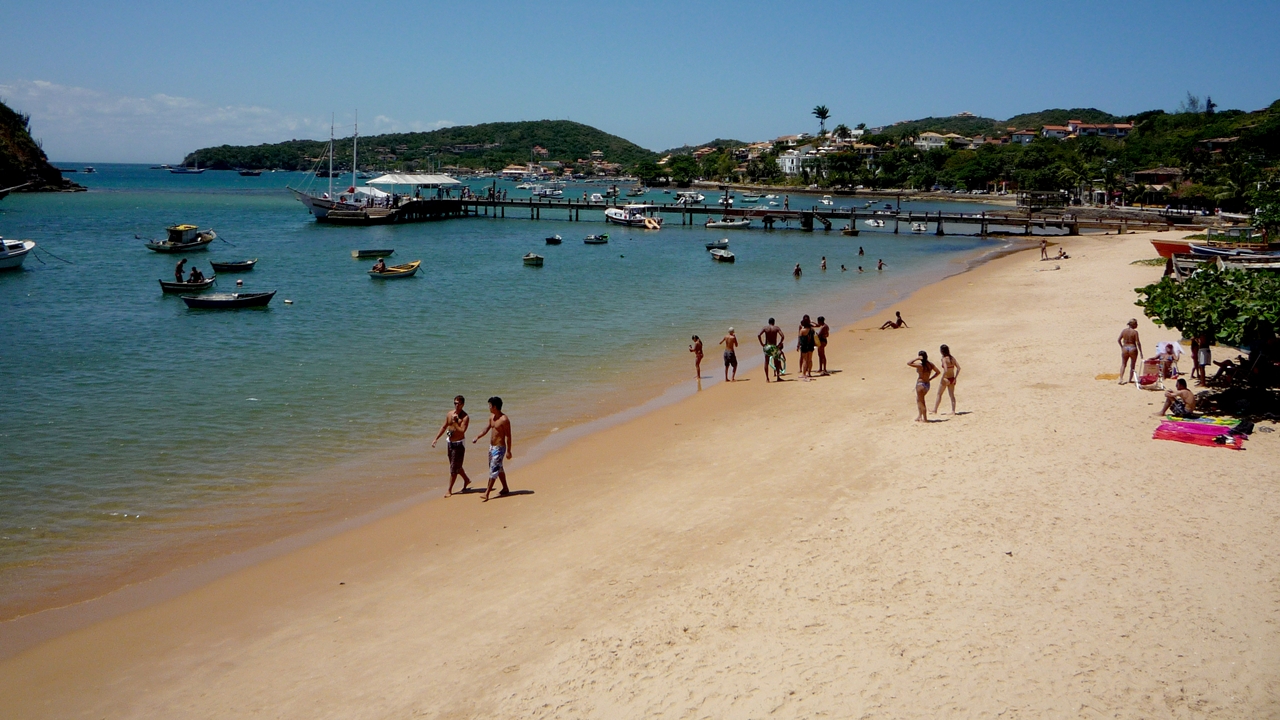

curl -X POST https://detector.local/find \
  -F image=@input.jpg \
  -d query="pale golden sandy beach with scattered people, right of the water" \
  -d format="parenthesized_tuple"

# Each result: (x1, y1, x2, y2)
(0, 228, 1280, 719)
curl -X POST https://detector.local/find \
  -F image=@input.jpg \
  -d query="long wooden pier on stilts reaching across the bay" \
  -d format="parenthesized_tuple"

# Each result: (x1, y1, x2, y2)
(307, 197, 1171, 236)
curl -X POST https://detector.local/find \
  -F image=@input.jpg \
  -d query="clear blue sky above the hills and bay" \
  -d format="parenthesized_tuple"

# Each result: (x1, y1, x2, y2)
(0, 0, 1280, 163)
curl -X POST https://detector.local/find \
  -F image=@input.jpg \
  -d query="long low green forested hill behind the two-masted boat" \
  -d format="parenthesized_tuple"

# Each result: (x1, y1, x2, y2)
(184, 120, 655, 170)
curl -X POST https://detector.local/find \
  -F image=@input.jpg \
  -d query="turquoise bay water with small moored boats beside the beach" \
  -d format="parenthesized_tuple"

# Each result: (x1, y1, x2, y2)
(0, 165, 1000, 619)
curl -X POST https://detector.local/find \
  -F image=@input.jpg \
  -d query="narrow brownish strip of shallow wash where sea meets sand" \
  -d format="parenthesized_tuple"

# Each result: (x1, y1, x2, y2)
(0, 240, 1018, 657)
